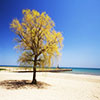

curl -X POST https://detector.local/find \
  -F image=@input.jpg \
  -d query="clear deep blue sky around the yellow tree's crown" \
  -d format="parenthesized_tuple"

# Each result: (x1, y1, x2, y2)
(0, 0, 100, 68)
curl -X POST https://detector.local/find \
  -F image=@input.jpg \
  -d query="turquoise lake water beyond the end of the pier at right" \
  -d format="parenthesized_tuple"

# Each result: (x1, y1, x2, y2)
(61, 67, 100, 75)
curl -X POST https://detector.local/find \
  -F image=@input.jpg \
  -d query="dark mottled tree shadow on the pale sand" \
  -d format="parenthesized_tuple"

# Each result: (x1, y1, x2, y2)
(0, 80, 50, 89)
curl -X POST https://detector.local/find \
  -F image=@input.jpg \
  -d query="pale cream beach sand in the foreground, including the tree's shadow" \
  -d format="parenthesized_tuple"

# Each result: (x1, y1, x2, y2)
(0, 72, 100, 100)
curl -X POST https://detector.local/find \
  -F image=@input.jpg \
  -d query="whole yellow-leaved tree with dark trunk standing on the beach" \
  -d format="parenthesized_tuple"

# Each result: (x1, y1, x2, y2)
(10, 9, 63, 84)
